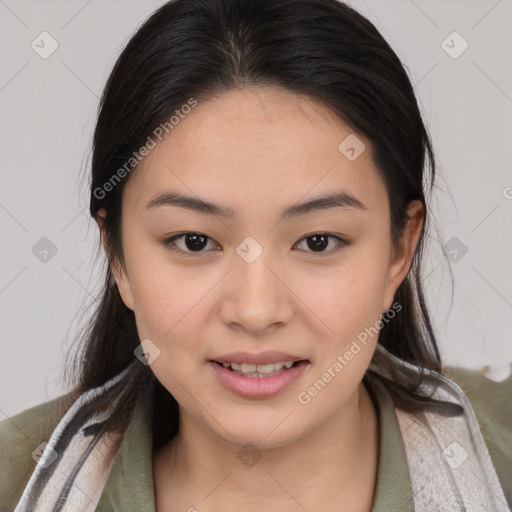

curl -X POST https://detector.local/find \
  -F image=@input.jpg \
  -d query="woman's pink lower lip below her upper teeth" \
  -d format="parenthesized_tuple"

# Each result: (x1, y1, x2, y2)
(208, 361, 309, 398)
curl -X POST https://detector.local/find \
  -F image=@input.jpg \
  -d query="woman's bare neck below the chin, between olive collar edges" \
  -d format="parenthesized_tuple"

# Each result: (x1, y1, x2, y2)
(153, 383, 379, 512)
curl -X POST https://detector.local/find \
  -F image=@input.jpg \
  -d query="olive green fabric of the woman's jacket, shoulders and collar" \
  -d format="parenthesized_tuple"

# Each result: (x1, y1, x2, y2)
(0, 367, 512, 512)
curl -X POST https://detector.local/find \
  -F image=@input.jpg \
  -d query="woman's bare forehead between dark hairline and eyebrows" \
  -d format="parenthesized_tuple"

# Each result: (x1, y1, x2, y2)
(123, 87, 387, 215)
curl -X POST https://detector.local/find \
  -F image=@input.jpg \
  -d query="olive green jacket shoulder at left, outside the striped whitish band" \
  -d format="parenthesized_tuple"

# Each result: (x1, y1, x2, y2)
(0, 393, 71, 512)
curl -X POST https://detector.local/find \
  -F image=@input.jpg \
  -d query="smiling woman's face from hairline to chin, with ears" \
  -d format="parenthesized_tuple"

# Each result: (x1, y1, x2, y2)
(101, 87, 422, 447)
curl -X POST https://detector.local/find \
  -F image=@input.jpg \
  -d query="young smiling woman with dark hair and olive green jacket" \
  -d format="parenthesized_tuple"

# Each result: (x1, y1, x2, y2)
(0, 0, 512, 512)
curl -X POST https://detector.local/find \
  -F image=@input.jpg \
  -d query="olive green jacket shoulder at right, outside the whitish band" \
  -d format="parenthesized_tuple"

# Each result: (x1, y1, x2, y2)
(443, 363, 512, 508)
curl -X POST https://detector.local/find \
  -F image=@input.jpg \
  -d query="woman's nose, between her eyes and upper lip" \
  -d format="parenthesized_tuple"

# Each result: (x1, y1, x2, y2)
(220, 251, 295, 336)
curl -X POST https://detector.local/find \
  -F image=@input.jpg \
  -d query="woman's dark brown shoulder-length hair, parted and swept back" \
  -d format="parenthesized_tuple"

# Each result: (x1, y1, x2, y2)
(63, 0, 460, 448)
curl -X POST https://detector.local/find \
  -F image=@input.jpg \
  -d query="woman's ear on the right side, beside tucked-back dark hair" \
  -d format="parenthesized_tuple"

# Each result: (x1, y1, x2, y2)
(382, 199, 425, 312)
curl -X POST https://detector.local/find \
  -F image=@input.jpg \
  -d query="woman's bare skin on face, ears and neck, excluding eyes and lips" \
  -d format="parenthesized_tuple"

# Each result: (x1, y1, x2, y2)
(98, 87, 423, 512)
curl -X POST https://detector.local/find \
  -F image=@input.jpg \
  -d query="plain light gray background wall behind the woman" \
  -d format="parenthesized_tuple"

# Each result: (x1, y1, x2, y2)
(0, 0, 512, 420)
